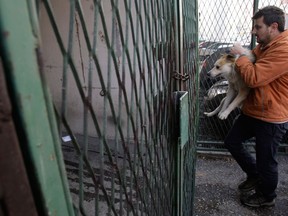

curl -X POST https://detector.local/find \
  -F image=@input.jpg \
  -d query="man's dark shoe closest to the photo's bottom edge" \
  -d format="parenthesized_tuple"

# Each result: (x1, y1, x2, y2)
(240, 193, 275, 207)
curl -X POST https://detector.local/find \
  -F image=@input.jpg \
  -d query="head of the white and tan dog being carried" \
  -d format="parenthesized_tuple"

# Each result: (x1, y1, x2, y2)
(207, 54, 236, 78)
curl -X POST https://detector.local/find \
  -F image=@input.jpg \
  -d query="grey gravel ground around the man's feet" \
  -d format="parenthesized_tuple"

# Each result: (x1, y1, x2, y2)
(194, 154, 288, 216)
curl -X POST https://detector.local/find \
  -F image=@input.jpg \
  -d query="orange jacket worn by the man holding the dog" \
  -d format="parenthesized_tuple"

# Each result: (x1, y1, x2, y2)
(236, 30, 288, 123)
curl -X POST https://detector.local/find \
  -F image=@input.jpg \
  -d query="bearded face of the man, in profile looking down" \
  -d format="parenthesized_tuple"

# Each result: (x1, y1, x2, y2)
(252, 17, 271, 46)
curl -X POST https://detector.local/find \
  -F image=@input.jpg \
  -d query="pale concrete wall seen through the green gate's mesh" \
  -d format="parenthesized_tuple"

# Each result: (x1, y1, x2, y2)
(40, 0, 166, 137)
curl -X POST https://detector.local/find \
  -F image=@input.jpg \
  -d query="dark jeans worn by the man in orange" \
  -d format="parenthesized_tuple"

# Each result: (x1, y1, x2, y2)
(225, 114, 288, 199)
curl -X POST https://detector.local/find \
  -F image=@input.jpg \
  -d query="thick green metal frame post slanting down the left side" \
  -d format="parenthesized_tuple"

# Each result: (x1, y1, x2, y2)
(0, 0, 74, 216)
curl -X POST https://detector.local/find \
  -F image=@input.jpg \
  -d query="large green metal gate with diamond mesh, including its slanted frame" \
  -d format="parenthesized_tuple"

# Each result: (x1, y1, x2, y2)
(0, 0, 198, 216)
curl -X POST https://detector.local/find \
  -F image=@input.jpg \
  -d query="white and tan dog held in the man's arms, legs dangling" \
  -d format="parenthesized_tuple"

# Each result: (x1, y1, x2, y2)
(204, 50, 255, 120)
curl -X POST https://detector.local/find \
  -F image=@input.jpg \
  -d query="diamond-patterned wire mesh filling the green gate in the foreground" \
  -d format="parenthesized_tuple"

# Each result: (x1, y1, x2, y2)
(38, 0, 197, 215)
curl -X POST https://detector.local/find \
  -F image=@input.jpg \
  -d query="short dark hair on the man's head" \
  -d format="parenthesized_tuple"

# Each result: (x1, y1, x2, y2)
(252, 6, 285, 32)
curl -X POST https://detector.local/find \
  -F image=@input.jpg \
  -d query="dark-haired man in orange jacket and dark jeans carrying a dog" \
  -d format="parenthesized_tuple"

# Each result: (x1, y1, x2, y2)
(225, 6, 288, 207)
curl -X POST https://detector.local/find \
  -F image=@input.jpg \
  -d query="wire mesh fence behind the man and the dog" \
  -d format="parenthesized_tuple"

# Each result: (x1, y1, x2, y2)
(198, 0, 288, 151)
